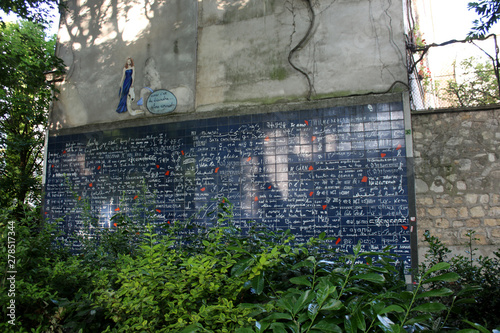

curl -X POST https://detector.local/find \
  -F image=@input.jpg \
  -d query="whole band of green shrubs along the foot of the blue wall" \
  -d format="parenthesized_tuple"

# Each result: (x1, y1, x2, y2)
(0, 199, 500, 333)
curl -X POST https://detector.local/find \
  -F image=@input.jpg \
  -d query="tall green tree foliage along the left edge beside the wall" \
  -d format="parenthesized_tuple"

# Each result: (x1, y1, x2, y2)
(0, 21, 63, 213)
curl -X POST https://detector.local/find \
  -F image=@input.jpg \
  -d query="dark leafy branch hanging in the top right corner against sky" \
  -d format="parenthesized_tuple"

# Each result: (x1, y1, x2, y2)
(467, 0, 500, 37)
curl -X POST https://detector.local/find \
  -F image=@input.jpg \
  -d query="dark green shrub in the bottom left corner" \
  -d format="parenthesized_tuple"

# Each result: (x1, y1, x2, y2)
(0, 206, 94, 332)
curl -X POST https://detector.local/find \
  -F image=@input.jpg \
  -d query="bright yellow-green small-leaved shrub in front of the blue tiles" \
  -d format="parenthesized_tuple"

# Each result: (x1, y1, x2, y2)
(92, 198, 291, 332)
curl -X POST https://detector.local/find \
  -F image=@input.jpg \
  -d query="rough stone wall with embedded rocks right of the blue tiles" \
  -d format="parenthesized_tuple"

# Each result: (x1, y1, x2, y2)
(412, 110, 500, 259)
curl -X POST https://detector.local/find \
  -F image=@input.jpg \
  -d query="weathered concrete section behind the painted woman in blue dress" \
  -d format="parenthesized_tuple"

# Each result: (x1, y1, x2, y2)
(50, 0, 197, 130)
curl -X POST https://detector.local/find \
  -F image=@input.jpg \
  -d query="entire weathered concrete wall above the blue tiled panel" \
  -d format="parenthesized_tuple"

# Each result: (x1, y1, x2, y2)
(50, 0, 407, 128)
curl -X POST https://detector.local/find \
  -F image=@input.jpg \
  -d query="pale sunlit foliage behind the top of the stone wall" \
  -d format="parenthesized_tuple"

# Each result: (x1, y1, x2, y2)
(443, 57, 500, 107)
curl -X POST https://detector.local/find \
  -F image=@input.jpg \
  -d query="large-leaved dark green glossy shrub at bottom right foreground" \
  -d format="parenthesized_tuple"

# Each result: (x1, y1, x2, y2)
(240, 244, 470, 332)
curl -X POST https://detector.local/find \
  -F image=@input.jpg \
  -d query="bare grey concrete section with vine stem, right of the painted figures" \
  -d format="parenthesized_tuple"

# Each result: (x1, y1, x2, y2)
(196, 0, 406, 110)
